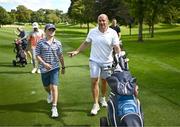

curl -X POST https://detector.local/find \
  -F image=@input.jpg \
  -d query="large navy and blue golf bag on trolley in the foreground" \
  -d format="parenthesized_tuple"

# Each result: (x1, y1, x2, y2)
(100, 52, 143, 127)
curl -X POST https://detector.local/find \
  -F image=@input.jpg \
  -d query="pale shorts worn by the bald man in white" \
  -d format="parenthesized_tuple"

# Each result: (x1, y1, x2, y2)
(89, 60, 112, 79)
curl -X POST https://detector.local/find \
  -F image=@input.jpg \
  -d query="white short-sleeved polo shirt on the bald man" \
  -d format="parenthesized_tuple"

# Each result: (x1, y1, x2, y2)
(86, 27, 119, 63)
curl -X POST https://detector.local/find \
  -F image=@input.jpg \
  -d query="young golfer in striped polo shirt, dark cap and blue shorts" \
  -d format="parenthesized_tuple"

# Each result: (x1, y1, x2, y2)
(36, 24, 65, 118)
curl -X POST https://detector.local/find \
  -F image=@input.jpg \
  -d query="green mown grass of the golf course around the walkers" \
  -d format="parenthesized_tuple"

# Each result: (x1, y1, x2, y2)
(0, 24, 180, 127)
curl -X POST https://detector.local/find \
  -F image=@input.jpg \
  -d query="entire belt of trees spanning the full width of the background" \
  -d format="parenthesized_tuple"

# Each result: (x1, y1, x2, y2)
(0, 0, 180, 42)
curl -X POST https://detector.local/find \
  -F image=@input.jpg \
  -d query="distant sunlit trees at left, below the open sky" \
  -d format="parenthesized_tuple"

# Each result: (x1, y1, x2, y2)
(0, 5, 66, 25)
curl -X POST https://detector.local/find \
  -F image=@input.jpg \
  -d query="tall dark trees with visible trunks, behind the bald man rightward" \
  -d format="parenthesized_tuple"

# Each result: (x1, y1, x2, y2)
(68, 0, 180, 42)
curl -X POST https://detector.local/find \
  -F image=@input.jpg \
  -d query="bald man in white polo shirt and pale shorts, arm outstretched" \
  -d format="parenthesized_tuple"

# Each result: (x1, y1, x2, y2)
(68, 14, 121, 115)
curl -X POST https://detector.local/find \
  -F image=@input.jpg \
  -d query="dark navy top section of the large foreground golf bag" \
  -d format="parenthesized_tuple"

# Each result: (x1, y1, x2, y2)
(107, 71, 136, 95)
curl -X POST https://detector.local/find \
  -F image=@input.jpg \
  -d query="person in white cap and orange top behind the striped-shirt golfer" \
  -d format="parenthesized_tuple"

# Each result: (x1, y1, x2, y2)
(28, 22, 44, 73)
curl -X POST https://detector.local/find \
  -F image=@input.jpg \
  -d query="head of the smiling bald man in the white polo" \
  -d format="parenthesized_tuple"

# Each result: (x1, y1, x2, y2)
(98, 15, 108, 30)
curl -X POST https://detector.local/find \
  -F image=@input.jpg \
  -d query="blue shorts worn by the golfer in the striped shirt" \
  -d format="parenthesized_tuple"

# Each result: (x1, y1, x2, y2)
(41, 68, 59, 87)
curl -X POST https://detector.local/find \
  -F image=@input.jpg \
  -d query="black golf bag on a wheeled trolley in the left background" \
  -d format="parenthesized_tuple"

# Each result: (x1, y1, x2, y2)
(12, 40, 27, 67)
